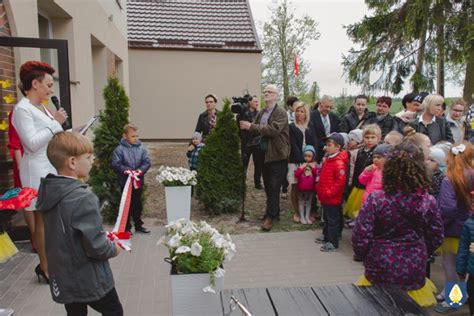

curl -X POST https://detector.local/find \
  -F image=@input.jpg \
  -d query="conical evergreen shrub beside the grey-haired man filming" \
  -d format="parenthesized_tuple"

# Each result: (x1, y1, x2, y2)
(197, 99, 245, 214)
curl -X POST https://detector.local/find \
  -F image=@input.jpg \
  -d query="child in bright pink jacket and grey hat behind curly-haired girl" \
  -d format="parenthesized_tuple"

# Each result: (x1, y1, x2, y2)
(359, 144, 393, 204)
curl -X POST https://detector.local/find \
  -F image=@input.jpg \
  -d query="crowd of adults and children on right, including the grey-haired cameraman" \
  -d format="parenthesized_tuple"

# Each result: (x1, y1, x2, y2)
(193, 85, 474, 313)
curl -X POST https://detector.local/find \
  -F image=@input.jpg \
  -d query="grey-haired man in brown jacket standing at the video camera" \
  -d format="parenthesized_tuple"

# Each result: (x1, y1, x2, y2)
(239, 85, 290, 231)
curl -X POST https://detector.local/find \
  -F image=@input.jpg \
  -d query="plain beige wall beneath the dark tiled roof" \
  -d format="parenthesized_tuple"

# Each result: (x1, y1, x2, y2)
(129, 48, 261, 139)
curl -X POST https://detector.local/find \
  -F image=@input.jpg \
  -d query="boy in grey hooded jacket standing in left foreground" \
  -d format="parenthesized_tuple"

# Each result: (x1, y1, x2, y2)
(36, 132, 123, 315)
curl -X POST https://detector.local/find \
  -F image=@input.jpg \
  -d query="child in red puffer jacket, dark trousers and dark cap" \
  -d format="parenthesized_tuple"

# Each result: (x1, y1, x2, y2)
(316, 133, 349, 252)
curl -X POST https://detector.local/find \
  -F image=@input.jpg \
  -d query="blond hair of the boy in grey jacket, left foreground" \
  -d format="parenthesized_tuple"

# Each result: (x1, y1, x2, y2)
(46, 132, 92, 171)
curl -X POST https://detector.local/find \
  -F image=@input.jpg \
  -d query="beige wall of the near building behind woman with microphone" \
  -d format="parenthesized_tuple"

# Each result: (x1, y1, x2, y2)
(4, 0, 129, 126)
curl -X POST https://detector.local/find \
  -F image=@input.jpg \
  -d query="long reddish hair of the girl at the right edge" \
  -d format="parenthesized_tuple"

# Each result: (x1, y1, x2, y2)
(446, 141, 474, 207)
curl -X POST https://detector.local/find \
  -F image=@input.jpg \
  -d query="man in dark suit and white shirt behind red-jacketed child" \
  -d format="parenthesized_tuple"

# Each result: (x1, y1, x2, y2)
(309, 95, 340, 163)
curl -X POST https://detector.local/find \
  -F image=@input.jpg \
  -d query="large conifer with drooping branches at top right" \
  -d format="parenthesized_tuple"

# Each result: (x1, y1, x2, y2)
(343, 0, 474, 99)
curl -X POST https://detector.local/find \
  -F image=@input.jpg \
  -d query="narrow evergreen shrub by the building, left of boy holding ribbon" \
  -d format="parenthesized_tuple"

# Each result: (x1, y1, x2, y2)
(89, 77, 129, 222)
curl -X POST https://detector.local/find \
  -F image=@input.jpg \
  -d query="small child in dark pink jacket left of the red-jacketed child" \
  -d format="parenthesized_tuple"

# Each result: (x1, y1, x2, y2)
(295, 145, 318, 224)
